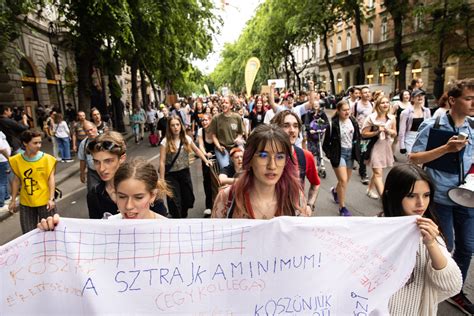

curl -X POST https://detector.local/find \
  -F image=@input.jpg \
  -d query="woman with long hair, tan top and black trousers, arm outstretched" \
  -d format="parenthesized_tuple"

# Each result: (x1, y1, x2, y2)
(160, 114, 211, 218)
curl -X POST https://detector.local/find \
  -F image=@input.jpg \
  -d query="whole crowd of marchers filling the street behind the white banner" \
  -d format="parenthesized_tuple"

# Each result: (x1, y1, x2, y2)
(0, 79, 474, 315)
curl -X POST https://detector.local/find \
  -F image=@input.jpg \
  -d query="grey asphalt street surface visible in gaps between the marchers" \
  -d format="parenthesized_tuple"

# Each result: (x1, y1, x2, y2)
(0, 134, 474, 315)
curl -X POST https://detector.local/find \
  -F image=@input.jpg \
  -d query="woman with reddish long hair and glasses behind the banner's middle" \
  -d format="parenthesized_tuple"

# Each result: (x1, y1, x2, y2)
(212, 125, 311, 219)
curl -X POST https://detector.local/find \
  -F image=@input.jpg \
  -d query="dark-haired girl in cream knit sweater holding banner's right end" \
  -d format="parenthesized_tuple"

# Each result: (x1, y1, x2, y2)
(382, 164, 462, 316)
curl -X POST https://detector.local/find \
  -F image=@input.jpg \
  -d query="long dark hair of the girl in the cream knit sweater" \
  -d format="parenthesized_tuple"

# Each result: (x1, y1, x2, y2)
(382, 164, 438, 220)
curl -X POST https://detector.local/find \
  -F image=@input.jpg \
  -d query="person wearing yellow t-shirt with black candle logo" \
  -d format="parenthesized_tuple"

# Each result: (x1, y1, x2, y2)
(8, 130, 56, 234)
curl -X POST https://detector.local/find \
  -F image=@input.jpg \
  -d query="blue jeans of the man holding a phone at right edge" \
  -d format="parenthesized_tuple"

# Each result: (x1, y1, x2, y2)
(434, 203, 474, 282)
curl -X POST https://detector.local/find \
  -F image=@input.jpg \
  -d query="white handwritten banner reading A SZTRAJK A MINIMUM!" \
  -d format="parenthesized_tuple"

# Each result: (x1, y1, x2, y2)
(0, 217, 420, 316)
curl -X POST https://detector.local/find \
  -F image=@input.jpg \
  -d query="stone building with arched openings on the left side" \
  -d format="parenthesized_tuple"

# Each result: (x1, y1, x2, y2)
(0, 7, 77, 126)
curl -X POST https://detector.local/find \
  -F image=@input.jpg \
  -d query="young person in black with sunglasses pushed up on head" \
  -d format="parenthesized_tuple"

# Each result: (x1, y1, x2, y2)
(87, 131, 167, 219)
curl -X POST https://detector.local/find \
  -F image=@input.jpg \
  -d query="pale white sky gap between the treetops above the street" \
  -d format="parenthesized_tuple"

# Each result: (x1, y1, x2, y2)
(194, 0, 264, 74)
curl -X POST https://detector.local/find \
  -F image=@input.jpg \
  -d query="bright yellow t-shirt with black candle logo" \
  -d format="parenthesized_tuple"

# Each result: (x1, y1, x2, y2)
(9, 153, 56, 207)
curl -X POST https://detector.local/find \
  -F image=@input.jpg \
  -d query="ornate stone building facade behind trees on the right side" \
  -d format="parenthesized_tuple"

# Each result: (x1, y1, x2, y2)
(295, 0, 474, 94)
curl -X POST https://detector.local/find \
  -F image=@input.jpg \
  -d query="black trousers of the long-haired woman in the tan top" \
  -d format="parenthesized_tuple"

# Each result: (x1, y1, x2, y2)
(165, 168, 194, 218)
